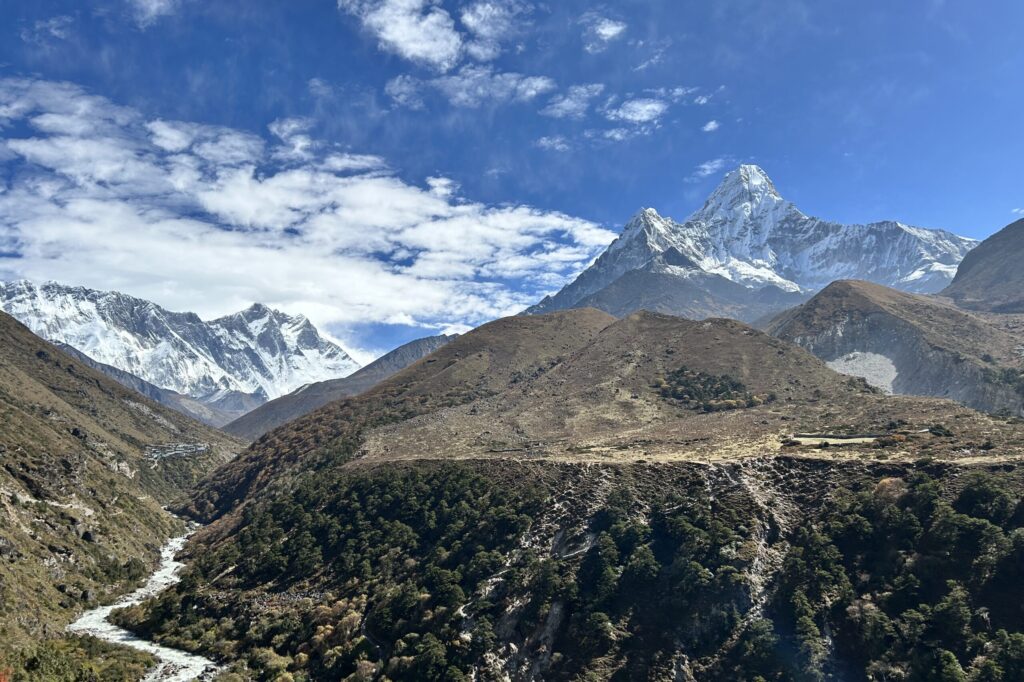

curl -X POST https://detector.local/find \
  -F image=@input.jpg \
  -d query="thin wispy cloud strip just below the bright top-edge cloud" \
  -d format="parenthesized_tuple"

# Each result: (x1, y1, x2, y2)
(385, 65, 555, 109)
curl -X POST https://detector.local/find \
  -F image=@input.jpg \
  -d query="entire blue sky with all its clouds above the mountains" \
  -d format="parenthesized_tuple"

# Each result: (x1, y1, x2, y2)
(0, 0, 1024, 352)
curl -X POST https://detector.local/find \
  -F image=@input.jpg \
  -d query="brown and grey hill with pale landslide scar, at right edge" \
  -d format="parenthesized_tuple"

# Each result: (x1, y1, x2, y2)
(767, 282, 1024, 415)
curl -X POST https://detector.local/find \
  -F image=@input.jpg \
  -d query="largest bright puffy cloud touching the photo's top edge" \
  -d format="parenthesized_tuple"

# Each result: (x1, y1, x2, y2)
(337, 0, 463, 72)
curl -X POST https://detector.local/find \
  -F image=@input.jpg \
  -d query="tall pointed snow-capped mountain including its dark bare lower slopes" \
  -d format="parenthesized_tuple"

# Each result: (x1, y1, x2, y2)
(527, 165, 977, 321)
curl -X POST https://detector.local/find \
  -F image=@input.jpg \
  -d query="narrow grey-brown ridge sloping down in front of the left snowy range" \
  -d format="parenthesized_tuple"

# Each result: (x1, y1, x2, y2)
(230, 335, 455, 440)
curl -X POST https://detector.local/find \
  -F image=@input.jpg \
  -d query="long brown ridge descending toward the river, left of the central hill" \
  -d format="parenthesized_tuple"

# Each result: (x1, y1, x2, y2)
(188, 308, 614, 518)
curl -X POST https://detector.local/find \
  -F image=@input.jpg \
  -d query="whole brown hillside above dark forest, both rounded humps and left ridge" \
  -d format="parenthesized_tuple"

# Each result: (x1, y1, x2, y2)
(191, 310, 1024, 530)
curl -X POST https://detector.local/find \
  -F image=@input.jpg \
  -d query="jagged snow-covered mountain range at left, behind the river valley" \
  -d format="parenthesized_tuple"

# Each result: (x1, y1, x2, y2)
(0, 281, 358, 413)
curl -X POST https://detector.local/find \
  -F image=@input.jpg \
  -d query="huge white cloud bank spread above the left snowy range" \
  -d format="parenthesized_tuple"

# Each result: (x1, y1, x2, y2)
(0, 79, 614, 345)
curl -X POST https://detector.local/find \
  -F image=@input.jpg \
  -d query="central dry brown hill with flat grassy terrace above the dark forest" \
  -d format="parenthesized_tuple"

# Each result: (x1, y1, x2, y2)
(364, 312, 1021, 461)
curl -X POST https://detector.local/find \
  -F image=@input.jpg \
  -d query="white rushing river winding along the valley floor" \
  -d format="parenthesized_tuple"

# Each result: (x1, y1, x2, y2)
(68, 535, 220, 682)
